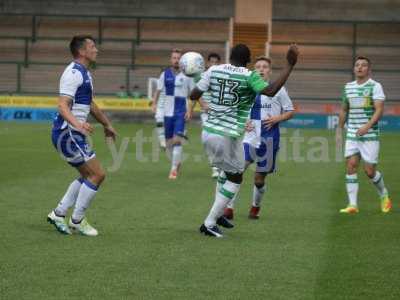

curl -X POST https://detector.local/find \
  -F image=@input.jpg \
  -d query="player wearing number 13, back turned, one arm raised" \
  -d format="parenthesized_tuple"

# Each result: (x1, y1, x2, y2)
(190, 44, 298, 237)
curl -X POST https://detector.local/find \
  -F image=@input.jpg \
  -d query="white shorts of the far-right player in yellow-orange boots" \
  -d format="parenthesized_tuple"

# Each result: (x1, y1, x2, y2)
(344, 140, 379, 164)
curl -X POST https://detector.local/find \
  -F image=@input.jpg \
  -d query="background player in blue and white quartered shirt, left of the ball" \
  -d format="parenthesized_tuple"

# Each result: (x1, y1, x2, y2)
(152, 49, 194, 179)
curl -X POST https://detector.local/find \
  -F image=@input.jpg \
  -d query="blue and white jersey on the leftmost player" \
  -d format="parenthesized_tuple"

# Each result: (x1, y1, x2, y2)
(53, 61, 93, 130)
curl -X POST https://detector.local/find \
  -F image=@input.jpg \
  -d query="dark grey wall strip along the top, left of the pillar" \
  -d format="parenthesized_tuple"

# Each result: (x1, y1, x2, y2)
(0, 0, 235, 18)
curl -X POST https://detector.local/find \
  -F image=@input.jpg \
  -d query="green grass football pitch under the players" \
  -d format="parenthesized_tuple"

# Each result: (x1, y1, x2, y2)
(0, 123, 400, 300)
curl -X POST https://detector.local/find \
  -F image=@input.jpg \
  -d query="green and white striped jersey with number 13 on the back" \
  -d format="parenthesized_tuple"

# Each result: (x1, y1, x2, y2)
(197, 64, 268, 137)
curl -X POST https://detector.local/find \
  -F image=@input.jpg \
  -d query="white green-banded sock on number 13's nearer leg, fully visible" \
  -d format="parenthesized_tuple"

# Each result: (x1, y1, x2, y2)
(204, 180, 240, 227)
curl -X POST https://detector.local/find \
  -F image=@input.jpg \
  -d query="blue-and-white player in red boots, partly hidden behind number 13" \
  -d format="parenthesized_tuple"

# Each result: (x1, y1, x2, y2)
(224, 56, 294, 220)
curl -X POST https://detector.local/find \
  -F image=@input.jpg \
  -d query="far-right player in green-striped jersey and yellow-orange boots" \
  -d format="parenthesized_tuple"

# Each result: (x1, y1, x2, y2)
(336, 56, 392, 214)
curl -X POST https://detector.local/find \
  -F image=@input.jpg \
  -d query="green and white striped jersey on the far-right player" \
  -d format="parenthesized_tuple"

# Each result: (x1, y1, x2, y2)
(342, 79, 385, 141)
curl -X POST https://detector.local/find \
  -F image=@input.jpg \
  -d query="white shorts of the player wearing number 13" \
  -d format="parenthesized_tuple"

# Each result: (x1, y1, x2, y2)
(201, 130, 245, 173)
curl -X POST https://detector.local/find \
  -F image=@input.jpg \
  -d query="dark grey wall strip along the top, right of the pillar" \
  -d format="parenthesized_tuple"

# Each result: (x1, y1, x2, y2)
(272, 0, 400, 21)
